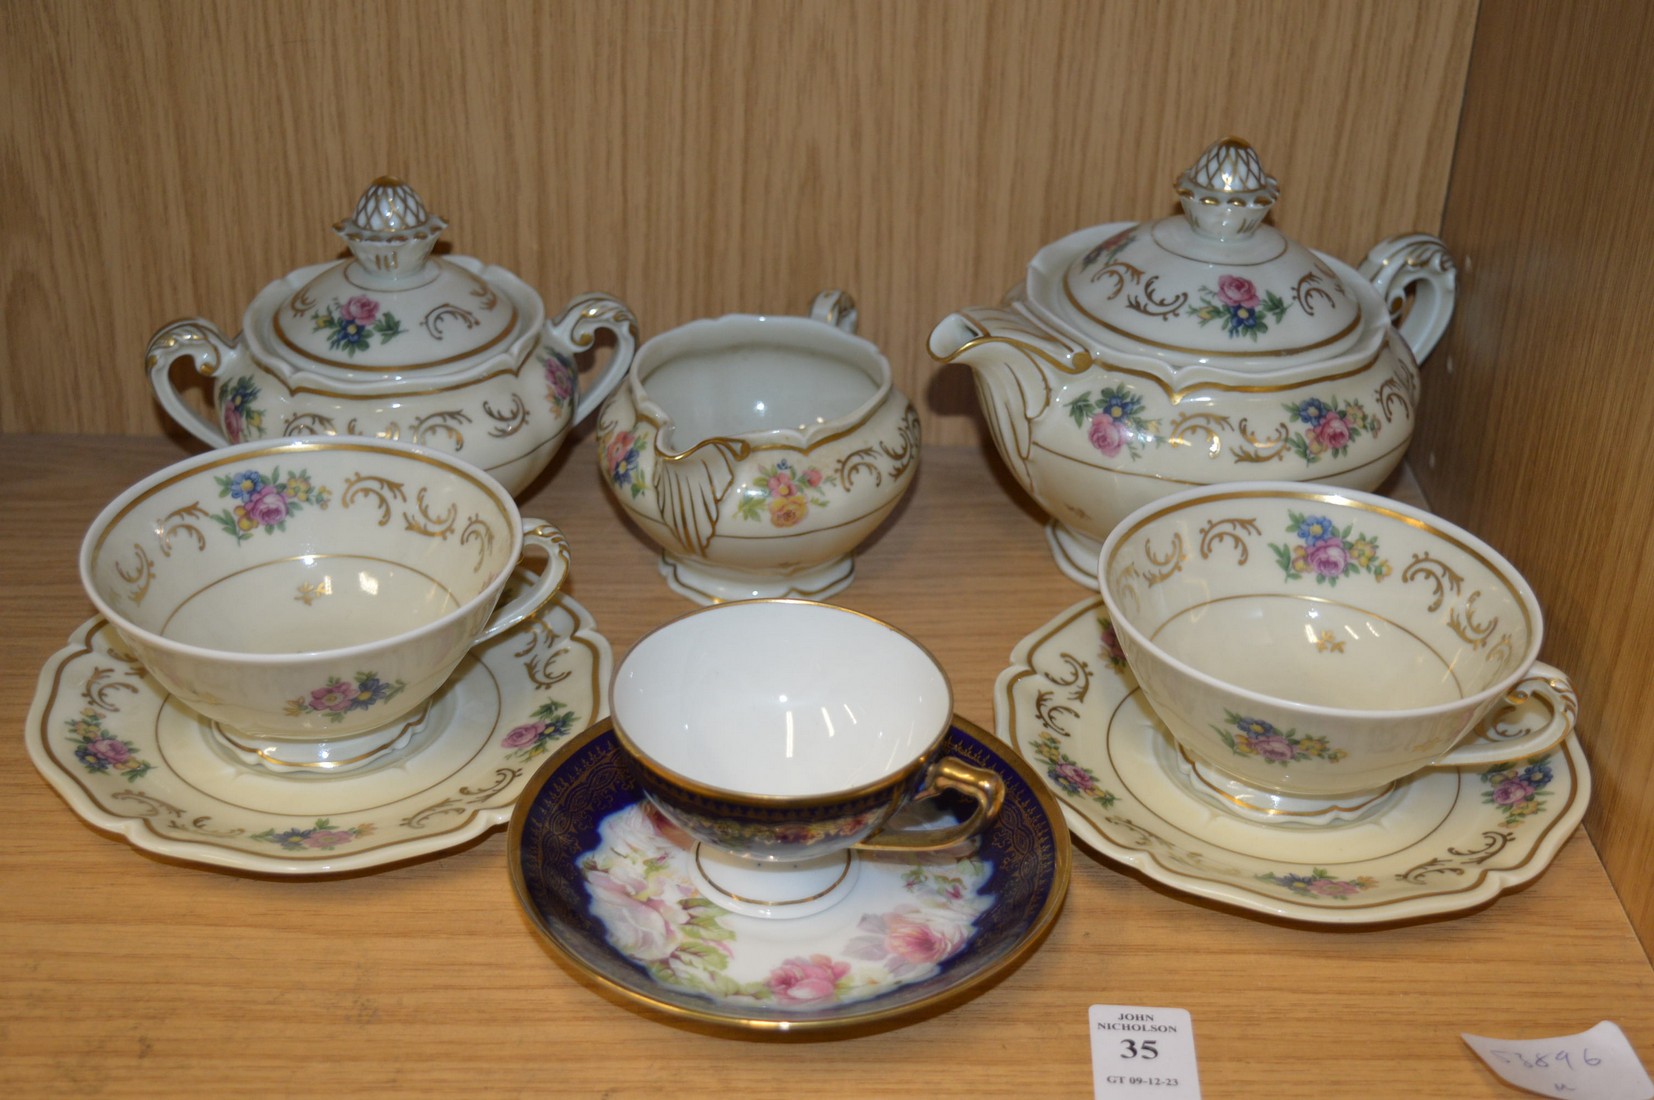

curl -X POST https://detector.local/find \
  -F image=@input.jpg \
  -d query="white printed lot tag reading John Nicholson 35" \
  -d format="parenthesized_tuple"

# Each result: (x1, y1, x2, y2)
(1090, 1004, 1201, 1100)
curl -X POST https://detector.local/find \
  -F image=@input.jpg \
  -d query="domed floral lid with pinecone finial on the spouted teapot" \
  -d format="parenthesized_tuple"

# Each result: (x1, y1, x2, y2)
(1042, 137, 1363, 372)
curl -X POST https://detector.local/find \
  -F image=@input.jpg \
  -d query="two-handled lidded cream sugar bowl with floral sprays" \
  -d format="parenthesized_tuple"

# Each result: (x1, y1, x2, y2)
(146, 177, 637, 495)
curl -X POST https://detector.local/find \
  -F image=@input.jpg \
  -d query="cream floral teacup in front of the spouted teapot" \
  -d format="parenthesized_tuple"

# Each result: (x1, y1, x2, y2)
(1100, 481, 1578, 811)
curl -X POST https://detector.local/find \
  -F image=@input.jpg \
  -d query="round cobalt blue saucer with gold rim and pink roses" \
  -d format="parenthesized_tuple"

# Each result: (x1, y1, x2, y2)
(506, 718, 1072, 1032)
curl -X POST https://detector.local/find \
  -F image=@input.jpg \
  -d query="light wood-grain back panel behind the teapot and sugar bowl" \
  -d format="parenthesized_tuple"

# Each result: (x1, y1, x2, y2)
(0, 0, 1475, 443)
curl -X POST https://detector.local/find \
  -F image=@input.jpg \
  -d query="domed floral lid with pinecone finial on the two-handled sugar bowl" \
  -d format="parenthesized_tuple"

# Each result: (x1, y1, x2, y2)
(270, 175, 518, 374)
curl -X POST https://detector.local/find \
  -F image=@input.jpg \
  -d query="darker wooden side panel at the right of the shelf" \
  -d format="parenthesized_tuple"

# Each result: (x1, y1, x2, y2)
(1411, 0, 1654, 948)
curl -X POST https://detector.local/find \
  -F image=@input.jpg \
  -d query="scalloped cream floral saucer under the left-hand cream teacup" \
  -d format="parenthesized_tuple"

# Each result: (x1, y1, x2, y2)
(25, 595, 610, 875)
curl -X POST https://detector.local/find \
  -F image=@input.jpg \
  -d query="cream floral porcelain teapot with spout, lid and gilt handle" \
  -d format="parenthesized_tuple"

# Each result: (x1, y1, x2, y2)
(930, 137, 1456, 589)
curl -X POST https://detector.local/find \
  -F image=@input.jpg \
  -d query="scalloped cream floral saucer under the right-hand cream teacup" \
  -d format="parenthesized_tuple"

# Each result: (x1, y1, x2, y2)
(994, 597, 1591, 925)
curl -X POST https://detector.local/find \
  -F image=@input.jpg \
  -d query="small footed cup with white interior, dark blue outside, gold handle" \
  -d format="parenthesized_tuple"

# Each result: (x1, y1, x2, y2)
(612, 600, 1004, 920)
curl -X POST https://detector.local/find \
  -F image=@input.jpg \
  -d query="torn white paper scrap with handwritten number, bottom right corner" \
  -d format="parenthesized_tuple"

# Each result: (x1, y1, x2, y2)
(1460, 1021, 1654, 1100)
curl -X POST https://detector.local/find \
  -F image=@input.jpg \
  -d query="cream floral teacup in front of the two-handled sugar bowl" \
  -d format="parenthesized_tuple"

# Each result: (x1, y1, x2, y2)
(81, 437, 569, 766)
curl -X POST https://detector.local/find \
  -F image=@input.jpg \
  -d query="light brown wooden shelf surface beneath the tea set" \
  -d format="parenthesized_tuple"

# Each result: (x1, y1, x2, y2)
(0, 435, 1654, 1098)
